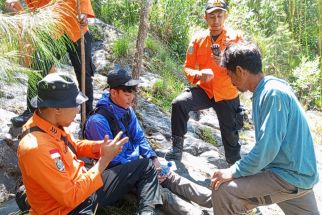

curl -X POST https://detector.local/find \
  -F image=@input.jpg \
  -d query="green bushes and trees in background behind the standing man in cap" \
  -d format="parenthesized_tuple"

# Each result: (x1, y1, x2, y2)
(94, 0, 322, 109)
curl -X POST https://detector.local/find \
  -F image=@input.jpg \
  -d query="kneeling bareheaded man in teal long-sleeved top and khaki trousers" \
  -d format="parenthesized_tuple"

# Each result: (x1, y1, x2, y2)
(212, 43, 319, 214)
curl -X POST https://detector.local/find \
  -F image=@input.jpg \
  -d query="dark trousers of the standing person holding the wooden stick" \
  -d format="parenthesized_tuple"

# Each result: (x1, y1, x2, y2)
(27, 31, 95, 114)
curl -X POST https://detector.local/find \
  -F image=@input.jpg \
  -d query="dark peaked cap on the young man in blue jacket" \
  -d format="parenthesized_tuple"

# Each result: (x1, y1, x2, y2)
(107, 69, 141, 88)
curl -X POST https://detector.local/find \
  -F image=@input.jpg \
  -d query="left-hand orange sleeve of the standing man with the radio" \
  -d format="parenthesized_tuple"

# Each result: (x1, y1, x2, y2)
(183, 34, 198, 84)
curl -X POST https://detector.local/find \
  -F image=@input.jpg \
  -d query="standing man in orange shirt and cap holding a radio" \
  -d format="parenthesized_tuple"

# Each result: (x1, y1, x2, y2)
(166, 0, 243, 164)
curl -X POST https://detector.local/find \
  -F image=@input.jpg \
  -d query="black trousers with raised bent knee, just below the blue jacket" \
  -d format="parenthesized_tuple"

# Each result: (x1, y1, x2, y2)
(69, 158, 162, 215)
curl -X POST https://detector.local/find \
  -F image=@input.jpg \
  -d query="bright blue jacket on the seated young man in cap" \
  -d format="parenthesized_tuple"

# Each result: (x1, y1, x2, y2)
(85, 93, 157, 166)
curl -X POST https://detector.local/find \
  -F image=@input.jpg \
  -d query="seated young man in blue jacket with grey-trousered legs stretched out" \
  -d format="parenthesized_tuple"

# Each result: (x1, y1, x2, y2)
(84, 69, 212, 215)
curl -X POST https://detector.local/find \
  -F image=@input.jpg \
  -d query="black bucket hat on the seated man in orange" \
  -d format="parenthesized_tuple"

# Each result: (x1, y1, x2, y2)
(31, 72, 88, 108)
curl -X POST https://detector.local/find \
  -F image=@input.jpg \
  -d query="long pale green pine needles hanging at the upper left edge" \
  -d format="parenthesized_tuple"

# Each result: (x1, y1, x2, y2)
(0, 6, 68, 81)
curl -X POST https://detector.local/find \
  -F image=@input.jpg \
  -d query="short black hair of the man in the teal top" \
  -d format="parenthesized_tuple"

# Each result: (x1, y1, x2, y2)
(221, 42, 262, 74)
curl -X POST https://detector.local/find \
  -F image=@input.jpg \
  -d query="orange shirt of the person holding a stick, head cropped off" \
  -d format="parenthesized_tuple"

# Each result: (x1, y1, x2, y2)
(26, 0, 95, 42)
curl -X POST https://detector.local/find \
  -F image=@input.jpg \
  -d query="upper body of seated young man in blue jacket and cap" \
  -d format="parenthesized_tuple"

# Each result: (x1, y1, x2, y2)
(85, 69, 160, 168)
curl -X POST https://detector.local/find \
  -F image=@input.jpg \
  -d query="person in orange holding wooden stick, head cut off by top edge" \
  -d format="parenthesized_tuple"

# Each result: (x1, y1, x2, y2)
(6, 0, 95, 127)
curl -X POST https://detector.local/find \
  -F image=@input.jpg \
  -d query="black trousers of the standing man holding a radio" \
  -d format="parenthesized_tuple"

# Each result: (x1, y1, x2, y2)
(171, 87, 243, 163)
